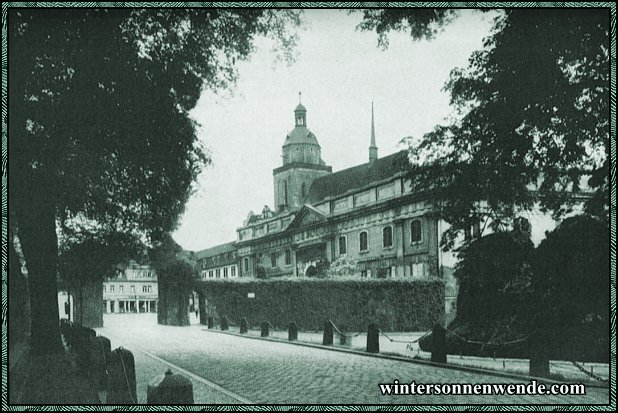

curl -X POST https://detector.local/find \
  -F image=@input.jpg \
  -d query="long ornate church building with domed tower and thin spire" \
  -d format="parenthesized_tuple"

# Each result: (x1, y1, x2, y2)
(196, 98, 456, 313)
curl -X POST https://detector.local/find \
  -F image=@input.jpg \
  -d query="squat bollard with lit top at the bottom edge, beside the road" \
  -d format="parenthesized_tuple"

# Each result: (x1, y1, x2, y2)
(146, 369, 194, 404)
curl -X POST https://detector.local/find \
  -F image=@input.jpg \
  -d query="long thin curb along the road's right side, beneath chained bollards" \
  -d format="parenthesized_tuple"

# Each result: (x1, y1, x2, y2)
(202, 328, 609, 389)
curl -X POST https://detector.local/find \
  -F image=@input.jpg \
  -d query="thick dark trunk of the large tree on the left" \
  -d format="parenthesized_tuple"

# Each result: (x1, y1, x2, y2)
(17, 196, 63, 354)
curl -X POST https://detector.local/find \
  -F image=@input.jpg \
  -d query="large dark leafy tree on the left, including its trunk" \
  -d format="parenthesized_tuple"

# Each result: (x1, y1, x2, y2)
(7, 9, 299, 353)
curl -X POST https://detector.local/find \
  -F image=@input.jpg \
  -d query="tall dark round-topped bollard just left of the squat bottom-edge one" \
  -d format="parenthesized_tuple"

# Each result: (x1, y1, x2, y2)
(107, 347, 137, 404)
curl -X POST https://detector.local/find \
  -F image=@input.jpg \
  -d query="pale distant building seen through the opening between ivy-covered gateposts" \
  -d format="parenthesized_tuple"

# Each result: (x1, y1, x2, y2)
(103, 261, 159, 313)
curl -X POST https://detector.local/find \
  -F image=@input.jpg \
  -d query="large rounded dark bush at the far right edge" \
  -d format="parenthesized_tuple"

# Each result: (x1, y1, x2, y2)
(531, 215, 611, 362)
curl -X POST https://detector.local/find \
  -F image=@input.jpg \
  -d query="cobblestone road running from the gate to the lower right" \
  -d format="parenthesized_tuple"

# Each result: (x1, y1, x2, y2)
(99, 315, 609, 404)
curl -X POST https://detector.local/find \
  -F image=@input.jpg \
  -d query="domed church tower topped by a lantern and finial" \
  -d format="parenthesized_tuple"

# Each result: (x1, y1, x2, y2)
(273, 93, 332, 211)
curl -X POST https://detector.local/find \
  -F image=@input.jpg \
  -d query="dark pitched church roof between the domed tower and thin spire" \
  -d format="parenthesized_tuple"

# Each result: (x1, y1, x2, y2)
(306, 151, 408, 204)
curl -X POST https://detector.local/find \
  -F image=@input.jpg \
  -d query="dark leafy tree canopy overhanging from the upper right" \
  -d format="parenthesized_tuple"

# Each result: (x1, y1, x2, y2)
(360, 9, 610, 247)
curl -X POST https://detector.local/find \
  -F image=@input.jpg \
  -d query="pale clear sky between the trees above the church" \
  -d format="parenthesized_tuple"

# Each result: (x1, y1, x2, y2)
(173, 9, 495, 251)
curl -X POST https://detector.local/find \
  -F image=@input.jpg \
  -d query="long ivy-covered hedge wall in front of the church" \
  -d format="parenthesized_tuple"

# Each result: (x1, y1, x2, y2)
(197, 278, 444, 331)
